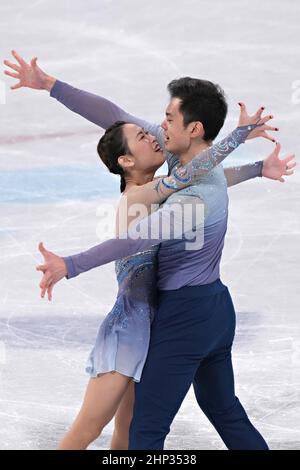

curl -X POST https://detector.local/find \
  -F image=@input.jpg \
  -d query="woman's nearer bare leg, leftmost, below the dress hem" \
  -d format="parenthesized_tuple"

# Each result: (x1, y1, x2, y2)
(58, 372, 131, 450)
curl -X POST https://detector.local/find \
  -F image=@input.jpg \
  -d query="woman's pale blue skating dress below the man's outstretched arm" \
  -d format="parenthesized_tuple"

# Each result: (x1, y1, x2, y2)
(86, 245, 158, 382)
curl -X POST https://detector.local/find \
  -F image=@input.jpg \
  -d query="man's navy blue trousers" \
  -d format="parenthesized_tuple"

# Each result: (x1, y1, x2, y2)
(129, 279, 268, 450)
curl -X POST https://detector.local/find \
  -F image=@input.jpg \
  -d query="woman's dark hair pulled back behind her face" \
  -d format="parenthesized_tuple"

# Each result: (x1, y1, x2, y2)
(97, 121, 130, 193)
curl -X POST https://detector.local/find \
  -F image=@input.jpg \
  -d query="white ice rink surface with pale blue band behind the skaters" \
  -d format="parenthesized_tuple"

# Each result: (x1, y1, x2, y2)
(0, 0, 300, 449)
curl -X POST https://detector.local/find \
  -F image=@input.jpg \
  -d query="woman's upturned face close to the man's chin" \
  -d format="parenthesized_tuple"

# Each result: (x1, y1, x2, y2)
(123, 124, 165, 171)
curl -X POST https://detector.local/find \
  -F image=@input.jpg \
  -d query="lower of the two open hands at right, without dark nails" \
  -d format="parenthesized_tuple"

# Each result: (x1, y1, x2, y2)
(262, 142, 296, 183)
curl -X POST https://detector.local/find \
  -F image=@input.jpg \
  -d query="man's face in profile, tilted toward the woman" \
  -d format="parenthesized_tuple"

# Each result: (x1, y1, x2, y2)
(161, 98, 191, 155)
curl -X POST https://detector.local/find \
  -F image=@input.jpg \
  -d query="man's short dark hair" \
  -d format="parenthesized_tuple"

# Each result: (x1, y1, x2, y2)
(168, 77, 227, 140)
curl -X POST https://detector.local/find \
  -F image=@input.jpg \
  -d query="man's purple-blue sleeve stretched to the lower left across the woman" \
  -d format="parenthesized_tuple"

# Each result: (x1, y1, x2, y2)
(64, 193, 204, 279)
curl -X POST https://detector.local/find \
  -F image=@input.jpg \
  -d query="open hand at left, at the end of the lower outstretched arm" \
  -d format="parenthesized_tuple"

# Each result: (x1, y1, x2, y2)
(36, 242, 68, 300)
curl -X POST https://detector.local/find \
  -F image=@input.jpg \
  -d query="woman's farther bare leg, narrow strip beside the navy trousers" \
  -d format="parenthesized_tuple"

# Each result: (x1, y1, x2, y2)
(110, 382, 134, 450)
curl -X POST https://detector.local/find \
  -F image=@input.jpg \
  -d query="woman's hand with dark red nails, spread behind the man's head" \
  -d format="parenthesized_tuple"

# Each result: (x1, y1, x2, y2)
(238, 103, 279, 142)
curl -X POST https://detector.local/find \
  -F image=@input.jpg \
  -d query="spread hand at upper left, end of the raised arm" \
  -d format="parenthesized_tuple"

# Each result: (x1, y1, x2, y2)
(4, 51, 56, 91)
